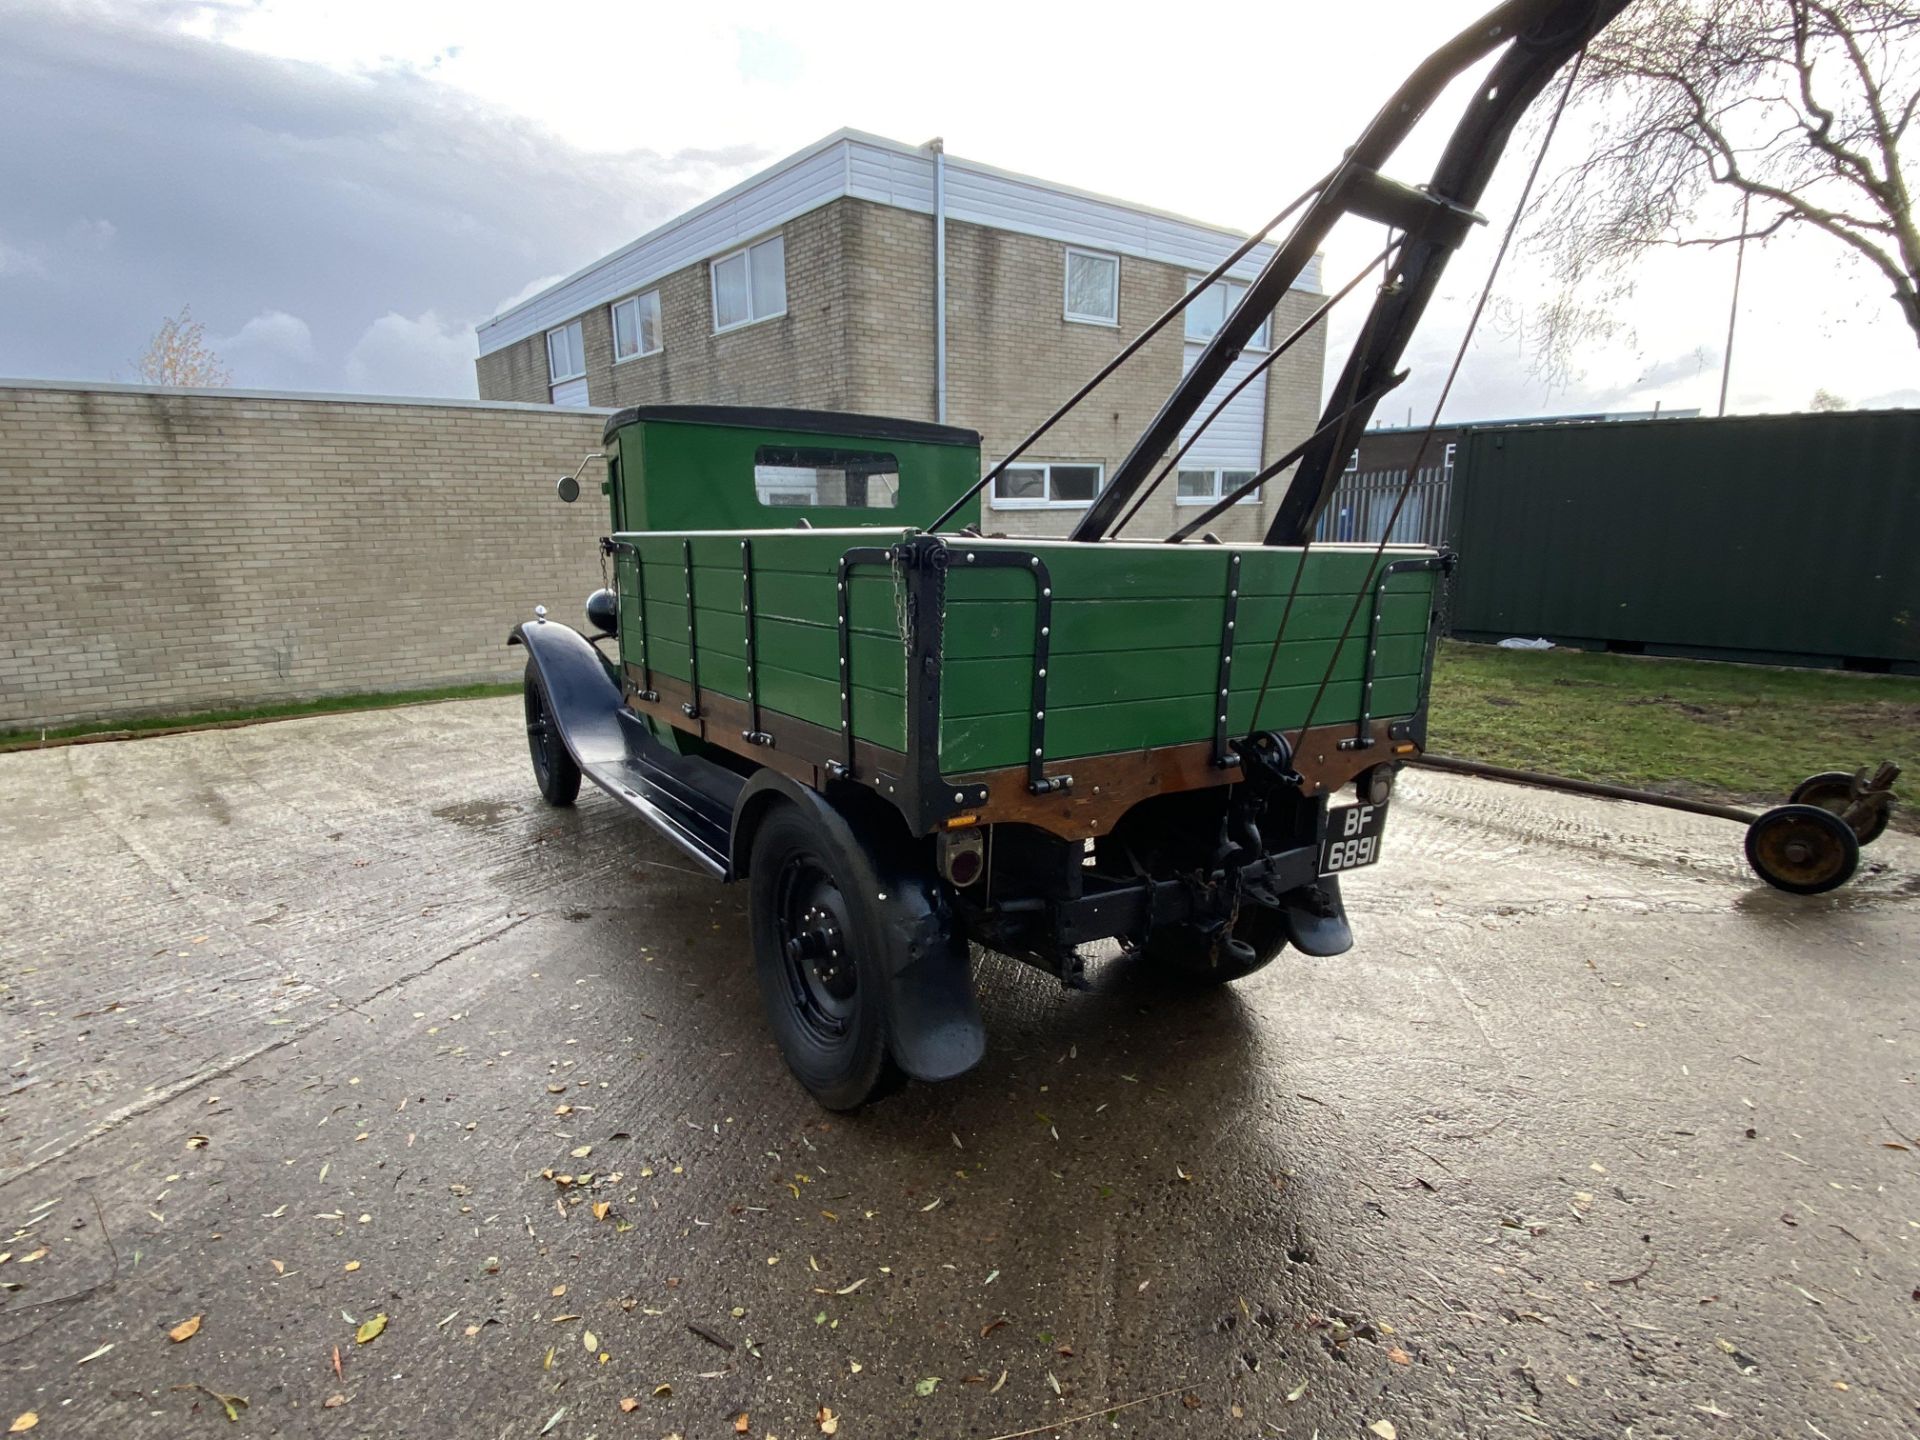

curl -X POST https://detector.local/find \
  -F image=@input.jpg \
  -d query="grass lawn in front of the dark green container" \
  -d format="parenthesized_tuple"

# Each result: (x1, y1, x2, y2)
(1428, 641, 1920, 831)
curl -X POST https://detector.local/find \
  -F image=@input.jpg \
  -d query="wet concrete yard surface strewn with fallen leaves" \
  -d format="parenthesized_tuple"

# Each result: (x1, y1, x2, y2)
(0, 701, 1920, 1440)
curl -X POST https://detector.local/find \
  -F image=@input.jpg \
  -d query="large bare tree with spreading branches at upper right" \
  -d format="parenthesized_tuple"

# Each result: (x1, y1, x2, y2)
(1528, 0, 1920, 380)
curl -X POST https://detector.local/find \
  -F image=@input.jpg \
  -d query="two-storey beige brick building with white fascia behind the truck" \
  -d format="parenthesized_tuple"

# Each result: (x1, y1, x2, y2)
(478, 131, 1325, 540)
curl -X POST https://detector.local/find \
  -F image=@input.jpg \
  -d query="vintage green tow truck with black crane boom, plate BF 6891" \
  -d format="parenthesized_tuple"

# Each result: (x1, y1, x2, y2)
(513, 0, 1624, 1108)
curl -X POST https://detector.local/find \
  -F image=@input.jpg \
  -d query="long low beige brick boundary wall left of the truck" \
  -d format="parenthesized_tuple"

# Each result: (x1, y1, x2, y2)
(0, 386, 605, 730)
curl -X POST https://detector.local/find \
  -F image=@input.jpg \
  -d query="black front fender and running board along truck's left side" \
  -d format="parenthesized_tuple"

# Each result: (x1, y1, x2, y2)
(507, 620, 747, 879)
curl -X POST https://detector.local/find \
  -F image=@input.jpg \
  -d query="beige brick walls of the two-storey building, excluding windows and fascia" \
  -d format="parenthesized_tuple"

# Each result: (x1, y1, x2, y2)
(480, 198, 1327, 541)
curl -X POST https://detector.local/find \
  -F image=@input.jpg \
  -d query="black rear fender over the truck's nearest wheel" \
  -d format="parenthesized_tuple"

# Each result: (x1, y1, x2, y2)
(732, 770, 987, 1081)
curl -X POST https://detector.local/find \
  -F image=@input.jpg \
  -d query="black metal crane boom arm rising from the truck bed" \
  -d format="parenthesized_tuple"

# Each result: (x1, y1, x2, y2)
(1071, 0, 1632, 545)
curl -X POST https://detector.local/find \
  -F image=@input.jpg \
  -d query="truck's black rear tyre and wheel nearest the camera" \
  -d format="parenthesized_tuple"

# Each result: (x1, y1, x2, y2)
(749, 804, 900, 1110)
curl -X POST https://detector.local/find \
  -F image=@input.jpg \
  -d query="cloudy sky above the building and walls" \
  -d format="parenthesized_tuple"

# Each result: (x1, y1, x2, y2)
(0, 0, 1920, 420)
